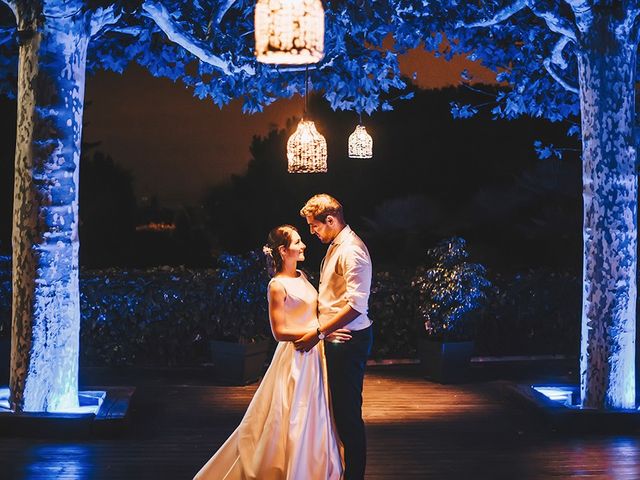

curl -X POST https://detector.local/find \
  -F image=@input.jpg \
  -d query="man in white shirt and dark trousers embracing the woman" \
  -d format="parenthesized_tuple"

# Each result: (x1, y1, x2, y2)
(295, 194, 373, 480)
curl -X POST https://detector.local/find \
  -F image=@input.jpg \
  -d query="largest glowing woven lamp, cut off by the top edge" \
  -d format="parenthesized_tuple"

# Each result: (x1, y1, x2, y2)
(255, 0, 324, 65)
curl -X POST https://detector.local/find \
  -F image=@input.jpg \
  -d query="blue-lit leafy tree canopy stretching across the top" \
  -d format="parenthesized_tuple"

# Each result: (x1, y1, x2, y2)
(0, 0, 612, 129)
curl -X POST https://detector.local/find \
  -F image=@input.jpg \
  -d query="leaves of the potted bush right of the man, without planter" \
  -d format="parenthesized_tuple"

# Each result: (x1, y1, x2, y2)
(411, 237, 491, 341)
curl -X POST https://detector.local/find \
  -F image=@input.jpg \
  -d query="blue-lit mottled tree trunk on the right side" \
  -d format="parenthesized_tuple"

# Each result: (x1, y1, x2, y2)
(578, 22, 638, 409)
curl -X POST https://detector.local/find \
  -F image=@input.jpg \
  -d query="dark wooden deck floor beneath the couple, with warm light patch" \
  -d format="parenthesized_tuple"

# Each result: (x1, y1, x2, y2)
(0, 367, 640, 480)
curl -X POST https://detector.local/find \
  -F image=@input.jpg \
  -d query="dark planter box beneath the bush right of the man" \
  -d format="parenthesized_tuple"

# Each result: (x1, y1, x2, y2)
(418, 339, 474, 383)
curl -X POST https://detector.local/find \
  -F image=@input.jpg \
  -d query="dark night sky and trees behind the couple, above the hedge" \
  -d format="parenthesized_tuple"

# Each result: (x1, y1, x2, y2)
(0, 86, 582, 272)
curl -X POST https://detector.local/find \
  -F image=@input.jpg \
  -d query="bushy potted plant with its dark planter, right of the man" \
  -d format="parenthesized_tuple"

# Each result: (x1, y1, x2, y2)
(412, 237, 491, 383)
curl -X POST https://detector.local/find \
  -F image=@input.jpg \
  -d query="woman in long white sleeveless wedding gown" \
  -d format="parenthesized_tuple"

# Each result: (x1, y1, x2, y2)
(194, 225, 349, 480)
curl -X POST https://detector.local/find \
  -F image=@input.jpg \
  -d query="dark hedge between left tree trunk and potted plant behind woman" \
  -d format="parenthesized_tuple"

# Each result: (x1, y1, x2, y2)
(80, 267, 217, 365)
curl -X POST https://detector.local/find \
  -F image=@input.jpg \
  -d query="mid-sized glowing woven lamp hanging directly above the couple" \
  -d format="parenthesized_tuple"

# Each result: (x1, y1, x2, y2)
(287, 118, 327, 173)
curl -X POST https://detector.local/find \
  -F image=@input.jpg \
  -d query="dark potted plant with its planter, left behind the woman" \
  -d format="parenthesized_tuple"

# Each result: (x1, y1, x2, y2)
(207, 251, 272, 385)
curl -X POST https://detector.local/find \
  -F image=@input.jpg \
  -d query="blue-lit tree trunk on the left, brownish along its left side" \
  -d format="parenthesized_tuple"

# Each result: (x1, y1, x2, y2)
(10, 1, 89, 412)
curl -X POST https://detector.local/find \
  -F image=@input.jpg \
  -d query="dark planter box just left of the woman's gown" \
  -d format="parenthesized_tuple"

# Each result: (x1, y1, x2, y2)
(209, 339, 271, 385)
